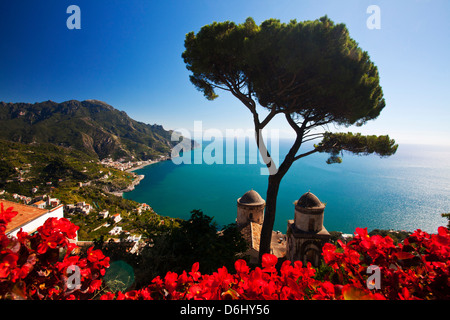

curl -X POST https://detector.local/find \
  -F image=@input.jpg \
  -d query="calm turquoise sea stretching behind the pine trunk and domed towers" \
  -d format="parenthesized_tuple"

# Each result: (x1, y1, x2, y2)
(124, 141, 450, 233)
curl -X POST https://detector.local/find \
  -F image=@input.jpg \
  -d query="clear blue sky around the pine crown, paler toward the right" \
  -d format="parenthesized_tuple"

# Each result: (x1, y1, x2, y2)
(0, 0, 450, 144)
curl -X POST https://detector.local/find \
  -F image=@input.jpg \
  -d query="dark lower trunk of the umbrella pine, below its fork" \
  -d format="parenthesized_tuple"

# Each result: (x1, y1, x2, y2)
(259, 174, 282, 264)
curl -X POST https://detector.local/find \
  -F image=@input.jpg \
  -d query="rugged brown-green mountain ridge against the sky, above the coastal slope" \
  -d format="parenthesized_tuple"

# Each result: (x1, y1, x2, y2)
(0, 100, 187, 160)
